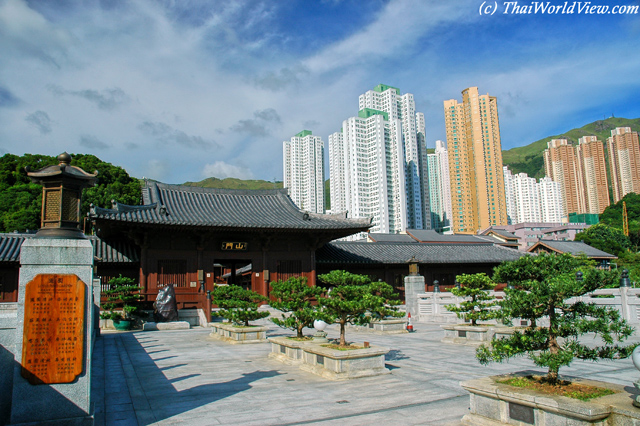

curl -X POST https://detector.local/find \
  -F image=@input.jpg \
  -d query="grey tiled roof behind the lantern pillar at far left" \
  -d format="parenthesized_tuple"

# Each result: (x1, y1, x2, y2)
(0, 233, 140, 263)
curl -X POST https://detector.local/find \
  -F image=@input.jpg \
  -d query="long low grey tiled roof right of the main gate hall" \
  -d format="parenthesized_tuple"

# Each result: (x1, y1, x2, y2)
(316, 241, 527, 264)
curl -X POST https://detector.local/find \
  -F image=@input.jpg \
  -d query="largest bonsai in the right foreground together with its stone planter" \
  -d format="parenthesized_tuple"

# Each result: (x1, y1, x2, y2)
(462, 254, 635, 424)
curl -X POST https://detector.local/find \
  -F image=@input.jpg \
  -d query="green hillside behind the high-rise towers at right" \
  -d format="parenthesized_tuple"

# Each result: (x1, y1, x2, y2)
(502, 117, 640, 179)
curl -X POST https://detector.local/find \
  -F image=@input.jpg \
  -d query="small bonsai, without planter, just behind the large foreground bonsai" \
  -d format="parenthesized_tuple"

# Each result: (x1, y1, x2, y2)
(445, 273, 498, 325)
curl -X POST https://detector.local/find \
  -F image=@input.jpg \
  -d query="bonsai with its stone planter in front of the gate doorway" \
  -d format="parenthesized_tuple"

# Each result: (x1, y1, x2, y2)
(211, 285, 269, 343)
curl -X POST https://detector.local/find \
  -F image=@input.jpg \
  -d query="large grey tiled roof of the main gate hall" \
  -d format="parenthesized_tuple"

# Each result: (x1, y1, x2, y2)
(90, 181, 371, 236)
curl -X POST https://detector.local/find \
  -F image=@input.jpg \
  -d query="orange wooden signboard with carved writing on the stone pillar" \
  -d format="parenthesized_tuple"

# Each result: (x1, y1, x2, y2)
(22, 274, 86, 385)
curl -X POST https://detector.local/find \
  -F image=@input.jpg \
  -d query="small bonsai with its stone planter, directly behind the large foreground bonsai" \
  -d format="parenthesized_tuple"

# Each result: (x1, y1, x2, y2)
(442, 273, 498, 344)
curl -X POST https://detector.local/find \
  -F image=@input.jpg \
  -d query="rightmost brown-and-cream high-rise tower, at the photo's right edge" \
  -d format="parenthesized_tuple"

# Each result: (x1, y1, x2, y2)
(607, 127, 640, 203)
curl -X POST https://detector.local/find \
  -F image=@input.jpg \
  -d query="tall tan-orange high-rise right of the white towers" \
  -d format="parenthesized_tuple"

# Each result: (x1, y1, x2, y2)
(444, 87, 507, 234)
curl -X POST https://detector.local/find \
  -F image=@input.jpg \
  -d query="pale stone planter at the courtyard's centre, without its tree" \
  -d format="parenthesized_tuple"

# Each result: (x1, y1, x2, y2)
(300, 343, 391, 380)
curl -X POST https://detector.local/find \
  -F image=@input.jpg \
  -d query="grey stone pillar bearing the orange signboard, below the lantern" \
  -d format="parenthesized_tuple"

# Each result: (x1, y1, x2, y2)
(10, 238, 95, 425)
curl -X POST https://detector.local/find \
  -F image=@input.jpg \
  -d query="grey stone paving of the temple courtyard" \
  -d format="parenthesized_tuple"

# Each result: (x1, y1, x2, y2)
(91, 320, 640, 426)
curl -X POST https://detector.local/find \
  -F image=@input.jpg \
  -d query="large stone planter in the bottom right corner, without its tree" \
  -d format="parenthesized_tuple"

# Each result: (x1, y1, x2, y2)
(460, 371, 640, 426)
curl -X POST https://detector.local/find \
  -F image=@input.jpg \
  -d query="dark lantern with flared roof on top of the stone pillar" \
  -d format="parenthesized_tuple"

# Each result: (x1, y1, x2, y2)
(26, 152, 98, 239)
